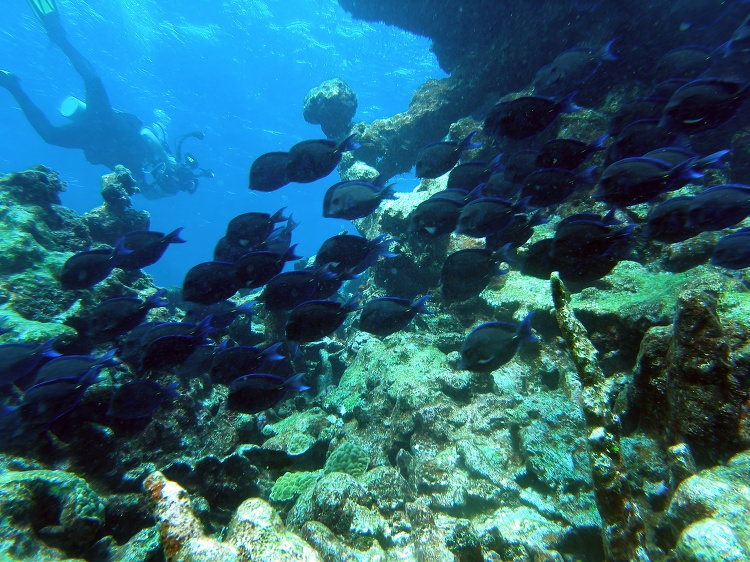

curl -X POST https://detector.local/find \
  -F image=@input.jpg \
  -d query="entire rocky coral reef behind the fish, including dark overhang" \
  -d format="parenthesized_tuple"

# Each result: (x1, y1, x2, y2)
(0, 0, 750, 552)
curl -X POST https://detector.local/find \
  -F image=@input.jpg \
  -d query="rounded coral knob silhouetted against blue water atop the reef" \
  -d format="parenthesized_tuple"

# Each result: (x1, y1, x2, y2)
(302, 78, 357, 139)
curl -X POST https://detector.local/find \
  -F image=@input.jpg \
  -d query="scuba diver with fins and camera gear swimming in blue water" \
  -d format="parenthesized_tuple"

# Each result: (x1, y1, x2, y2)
(0, 0, 213, 199)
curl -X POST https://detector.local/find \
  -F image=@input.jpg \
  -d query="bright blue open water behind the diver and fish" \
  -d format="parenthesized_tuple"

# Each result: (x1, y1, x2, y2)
(0, 0, 444, 285)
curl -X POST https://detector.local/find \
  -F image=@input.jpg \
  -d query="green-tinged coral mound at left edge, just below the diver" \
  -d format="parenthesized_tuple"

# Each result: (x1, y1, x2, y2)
(0, 166, 153, 343)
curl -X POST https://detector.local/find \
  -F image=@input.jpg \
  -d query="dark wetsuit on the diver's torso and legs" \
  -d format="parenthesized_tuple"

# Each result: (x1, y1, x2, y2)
(3, 16, 152, 183)
